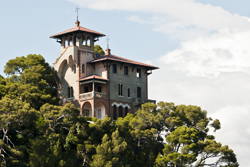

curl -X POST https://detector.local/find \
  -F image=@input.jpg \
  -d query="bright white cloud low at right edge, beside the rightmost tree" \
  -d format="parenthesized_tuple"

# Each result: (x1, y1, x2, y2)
(212, 105, 250, 166)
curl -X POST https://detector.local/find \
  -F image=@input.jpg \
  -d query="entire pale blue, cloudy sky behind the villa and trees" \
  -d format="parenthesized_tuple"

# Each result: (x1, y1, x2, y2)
(0, 0, 250, 166)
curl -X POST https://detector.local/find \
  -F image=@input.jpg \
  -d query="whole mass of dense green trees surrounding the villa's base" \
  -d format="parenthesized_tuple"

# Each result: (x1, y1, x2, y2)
(0, 55, 238, 167)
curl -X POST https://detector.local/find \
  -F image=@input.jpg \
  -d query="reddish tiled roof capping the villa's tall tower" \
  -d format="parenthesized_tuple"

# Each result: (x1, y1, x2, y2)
(50, 25, 105, 38)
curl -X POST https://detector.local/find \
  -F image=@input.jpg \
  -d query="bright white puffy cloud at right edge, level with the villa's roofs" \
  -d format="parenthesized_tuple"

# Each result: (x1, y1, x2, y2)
(160, 31, 250, 78)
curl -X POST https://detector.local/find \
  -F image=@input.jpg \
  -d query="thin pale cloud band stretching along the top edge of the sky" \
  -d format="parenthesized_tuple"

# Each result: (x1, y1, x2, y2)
(69, 0, 250, 33)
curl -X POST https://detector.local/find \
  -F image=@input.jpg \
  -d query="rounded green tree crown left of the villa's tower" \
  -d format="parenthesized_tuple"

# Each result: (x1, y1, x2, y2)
(0, 54, 59, 110)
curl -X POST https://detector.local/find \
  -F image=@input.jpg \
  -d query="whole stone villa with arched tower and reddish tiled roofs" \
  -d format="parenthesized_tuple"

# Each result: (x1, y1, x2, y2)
(51, 21, 158, 120)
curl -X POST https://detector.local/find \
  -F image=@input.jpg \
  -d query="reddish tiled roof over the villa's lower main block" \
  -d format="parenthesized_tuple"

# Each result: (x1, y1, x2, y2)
(88, 54, 159, 70)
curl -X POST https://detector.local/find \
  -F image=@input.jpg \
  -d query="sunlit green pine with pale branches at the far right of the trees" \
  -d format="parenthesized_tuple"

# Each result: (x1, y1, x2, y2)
(155, 102, 238, 167)
